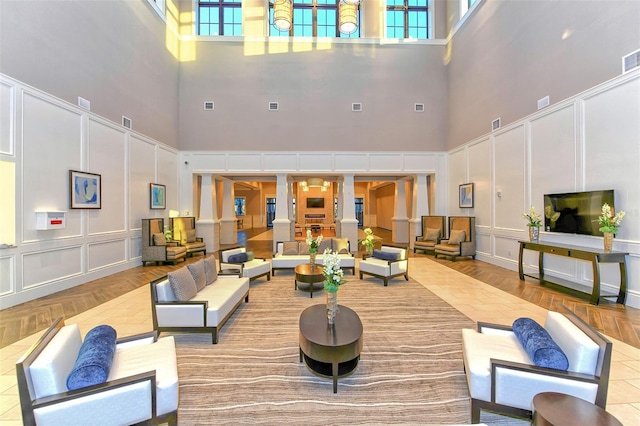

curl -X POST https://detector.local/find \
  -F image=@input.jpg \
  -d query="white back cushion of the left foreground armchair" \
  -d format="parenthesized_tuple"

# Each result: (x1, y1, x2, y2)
(29, 324, 82, 398)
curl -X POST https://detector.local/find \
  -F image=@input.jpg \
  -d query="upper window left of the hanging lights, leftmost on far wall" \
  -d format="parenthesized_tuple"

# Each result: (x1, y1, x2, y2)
(198, 0, 242, 36)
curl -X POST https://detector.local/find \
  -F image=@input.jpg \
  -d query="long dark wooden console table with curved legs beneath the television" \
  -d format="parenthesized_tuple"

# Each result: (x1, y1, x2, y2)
(518, 241, 629, 305)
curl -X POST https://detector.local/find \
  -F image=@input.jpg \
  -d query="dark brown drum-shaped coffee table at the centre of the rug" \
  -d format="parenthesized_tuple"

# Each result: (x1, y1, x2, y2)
(300, 305, 362, 393)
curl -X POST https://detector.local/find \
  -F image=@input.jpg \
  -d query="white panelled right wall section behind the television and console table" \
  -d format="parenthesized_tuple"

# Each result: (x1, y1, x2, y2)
(448, 70, 640, 308)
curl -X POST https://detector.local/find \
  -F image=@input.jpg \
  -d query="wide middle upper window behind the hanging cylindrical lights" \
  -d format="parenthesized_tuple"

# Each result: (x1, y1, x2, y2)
(269, 0, 360, 38)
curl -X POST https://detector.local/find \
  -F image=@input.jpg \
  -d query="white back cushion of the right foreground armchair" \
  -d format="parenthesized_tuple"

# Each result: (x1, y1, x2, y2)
(544, 311, 600, 375)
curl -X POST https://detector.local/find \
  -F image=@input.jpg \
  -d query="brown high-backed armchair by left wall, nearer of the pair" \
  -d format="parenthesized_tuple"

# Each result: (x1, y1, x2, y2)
(142, 218, 187, 266)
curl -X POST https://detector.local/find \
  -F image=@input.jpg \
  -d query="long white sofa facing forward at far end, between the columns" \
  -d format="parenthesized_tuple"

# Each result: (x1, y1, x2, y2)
(271, 238, 356, 275)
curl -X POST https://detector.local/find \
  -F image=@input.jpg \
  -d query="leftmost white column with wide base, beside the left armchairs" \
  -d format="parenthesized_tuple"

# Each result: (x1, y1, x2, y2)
(196, 173, 220, 253)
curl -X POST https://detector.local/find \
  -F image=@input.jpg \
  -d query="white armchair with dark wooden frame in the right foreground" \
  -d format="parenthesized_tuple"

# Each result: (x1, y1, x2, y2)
(462, 308, 612, 423)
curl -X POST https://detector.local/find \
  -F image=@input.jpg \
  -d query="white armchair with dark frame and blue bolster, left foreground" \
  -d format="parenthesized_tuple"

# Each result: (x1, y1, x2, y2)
(16, 318, 178, 426)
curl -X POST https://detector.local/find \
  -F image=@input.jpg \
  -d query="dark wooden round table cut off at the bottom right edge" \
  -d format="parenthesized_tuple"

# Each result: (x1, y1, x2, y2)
(533, 392, 622, 426)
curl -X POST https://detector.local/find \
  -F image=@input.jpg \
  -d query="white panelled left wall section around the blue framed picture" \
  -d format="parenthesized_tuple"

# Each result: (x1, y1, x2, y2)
(0, 74, 178, 308)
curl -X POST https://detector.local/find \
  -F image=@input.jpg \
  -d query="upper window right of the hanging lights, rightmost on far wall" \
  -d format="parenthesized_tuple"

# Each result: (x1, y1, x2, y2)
(386, 0, 432, 39)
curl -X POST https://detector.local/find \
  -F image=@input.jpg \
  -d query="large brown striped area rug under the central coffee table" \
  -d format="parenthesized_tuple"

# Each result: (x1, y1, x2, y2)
(175, 272, 524, 425)
